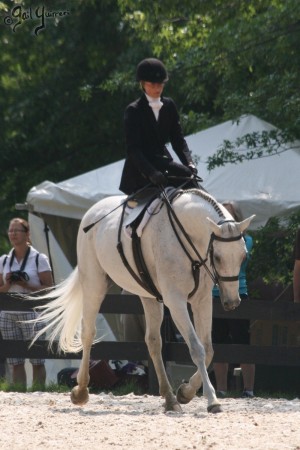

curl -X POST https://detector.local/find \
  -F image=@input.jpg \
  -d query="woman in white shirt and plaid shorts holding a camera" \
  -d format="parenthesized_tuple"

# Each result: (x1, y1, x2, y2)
(0, 217, 53, 387)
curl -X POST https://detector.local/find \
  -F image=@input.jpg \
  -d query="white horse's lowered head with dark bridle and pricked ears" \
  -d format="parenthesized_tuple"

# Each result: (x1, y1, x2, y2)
(207, 215, 255, 311)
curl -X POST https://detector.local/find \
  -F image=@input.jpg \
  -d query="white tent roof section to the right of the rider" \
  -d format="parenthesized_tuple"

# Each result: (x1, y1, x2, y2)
(187, 115, 300, 229)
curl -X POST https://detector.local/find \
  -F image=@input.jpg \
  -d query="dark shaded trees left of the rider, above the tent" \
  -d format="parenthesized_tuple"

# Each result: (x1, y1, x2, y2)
(0, 0, 141, 245)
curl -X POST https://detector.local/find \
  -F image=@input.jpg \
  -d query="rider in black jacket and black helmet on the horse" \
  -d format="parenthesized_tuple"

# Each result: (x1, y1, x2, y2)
(120, 58, 197, 195)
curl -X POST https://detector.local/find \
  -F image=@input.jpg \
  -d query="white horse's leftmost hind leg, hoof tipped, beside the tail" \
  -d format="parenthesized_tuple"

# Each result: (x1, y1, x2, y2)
(71, 299, 99, 405)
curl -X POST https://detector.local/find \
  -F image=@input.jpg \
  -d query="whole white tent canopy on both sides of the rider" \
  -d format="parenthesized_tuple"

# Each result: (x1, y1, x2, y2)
(26, 115, 300, 274)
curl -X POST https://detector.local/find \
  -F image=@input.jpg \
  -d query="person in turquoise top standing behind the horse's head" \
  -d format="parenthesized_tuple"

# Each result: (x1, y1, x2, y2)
(212, 202, 255, 398)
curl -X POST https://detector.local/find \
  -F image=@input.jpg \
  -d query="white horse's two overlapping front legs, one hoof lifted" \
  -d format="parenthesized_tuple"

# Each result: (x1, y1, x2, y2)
(170, 302, 221, 412)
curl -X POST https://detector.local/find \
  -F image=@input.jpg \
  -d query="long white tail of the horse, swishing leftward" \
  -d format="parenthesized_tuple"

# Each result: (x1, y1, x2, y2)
(31, 267, 83, 353)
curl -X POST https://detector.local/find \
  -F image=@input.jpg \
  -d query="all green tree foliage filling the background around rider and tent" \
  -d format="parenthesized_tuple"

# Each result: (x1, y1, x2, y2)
(0, 0, 300, 282)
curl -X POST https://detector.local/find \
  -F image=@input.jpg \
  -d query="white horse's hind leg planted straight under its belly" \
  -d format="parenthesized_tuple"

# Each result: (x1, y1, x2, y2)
(141, 297, 182, 412)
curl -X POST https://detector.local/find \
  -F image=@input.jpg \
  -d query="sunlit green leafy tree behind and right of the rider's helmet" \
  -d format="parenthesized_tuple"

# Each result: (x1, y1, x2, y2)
(119, 0, 300, 149)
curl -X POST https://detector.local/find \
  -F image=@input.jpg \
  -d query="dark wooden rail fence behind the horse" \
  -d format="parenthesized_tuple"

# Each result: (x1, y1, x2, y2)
(0, 294, 300, 392)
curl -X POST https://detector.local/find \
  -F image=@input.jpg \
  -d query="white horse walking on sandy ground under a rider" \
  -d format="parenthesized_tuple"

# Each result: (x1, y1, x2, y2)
(31, 189, 254, 412)
